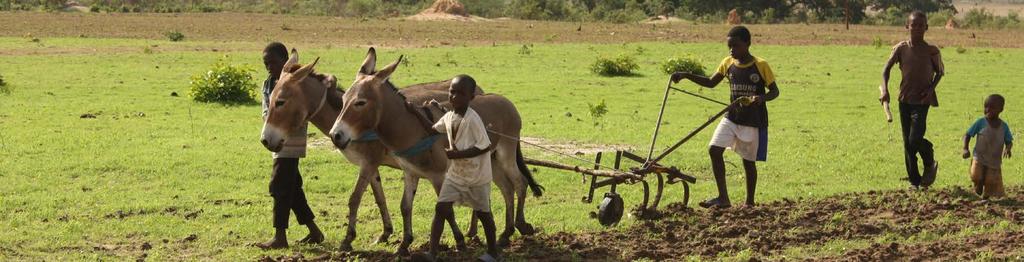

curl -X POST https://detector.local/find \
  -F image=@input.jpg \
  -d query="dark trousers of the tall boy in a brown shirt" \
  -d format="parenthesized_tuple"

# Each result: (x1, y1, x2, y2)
(899, 102, 935, 185)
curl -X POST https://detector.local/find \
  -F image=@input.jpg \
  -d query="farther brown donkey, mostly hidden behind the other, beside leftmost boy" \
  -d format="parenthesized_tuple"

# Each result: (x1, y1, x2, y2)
(261, 49, 473, 251)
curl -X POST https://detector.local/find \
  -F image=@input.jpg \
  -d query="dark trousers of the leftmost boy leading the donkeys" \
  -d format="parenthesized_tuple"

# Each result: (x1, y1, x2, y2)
(270, 159, 314, 228)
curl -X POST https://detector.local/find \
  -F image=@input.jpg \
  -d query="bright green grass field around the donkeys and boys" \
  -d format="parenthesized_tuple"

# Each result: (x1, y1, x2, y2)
(0, 30, 1024, 261)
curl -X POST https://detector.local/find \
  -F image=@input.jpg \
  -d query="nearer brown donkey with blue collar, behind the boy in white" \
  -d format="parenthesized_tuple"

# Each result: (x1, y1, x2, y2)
(331, 48, 543, 254)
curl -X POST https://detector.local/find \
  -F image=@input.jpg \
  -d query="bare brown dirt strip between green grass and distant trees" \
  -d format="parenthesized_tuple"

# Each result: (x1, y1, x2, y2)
(0, 12, 1024, 48)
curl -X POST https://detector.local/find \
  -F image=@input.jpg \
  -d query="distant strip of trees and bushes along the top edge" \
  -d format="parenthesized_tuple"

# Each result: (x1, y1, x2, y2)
(6, 0, 1024, 29)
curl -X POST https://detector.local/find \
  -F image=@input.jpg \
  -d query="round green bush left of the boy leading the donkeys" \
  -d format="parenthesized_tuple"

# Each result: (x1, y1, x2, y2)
(188, 61, 256, 104)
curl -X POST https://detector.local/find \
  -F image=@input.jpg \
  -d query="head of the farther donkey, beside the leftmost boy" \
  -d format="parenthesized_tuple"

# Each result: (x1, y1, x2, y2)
(260, 49, 319, 151)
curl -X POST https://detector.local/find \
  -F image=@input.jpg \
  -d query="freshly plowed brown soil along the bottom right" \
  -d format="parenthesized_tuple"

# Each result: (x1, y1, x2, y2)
(256, 187, 1024, 261)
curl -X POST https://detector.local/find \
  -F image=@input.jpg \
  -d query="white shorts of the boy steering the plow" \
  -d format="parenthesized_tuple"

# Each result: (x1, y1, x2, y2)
(709, 118, 768, 161)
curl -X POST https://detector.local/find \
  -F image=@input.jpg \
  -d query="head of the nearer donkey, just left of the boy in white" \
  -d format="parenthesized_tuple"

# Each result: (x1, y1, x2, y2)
(331, 48, 401, 149)
